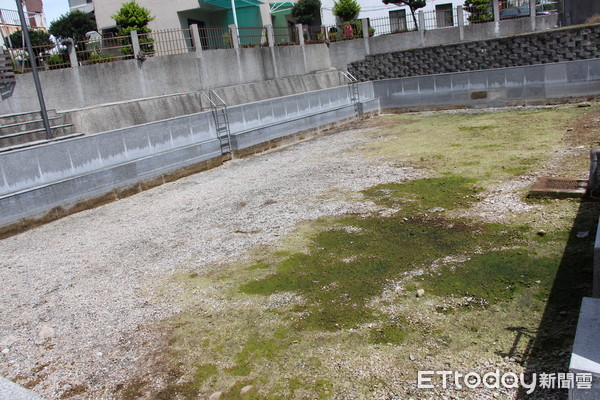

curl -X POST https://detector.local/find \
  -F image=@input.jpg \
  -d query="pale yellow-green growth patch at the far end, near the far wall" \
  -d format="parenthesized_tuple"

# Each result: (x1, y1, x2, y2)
(367, 107, 589, 187)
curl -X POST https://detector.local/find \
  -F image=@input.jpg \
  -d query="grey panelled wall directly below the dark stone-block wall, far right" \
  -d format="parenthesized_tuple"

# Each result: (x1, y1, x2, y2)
(373, 59, 600, 110)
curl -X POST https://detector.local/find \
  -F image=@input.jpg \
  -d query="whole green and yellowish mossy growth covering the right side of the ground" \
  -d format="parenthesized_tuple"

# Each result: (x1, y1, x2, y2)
(123, 105, 600, 399)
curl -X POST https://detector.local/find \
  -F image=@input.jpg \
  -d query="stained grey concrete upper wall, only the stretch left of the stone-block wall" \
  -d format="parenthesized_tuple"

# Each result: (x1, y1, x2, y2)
(0, 45, 331, 114)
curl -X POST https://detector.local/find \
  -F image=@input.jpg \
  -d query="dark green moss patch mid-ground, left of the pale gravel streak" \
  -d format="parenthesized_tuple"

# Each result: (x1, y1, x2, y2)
(240, 217, 494, 331)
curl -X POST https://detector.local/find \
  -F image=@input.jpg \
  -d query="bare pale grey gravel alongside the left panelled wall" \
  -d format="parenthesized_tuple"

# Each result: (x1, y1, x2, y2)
(0, 123, 424, 399)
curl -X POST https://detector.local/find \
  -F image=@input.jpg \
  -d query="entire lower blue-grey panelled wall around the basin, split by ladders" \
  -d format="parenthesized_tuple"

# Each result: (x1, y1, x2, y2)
(0, 59, 600, 228)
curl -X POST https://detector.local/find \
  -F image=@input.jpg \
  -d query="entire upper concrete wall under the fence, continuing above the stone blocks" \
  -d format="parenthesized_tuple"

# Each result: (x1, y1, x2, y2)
(0, 15, 556, 115)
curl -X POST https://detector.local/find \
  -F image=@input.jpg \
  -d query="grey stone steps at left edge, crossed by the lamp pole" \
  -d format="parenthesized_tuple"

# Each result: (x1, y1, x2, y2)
(0, 110, 82, 152)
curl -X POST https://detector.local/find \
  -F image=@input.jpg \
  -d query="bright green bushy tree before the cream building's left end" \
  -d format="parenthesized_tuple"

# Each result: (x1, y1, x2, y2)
(112, 0, 154, 54)
